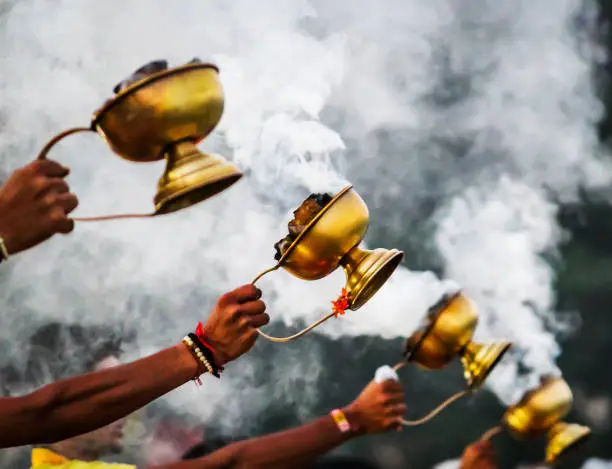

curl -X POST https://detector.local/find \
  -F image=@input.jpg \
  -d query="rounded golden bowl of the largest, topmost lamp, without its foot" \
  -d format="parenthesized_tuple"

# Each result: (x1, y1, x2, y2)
(91, 63, 225, 162)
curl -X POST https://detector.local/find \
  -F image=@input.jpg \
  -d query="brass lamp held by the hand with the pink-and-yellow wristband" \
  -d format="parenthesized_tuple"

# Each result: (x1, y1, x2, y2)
(395, 291, 512, 426)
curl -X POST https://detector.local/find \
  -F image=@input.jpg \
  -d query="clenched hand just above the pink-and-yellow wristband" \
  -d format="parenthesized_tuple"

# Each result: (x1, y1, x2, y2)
(344, 380, 406, 434)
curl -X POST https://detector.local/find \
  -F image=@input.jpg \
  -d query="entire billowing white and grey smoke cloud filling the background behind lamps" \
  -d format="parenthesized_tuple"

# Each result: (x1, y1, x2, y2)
(0, 0, 611, 425)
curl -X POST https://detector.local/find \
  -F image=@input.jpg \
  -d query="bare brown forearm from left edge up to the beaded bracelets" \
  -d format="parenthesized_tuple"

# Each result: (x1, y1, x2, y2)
(0, 344, 197, 448)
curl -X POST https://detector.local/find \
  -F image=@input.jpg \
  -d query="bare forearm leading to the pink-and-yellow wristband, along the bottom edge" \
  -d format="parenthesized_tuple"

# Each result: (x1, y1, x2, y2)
(163, 412, 357, 469)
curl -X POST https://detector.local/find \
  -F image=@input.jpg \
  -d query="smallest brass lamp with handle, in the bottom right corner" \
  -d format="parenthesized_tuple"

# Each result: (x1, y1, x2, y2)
(481, 376, 591, 464)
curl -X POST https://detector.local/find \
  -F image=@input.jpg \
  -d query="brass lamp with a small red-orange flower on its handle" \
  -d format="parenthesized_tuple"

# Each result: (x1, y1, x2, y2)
(253, 186, 404, 342)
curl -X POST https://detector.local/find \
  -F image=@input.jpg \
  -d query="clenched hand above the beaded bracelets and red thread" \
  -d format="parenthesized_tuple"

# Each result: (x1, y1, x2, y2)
(204, 284, 270, 366)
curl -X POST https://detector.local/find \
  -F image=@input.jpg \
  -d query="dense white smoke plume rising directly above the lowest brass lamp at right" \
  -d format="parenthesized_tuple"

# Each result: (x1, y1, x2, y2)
(436, 179, 562, 403)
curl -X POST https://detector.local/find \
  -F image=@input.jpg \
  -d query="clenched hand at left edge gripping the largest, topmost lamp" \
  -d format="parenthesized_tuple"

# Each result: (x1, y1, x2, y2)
(0, 160, 78, 254)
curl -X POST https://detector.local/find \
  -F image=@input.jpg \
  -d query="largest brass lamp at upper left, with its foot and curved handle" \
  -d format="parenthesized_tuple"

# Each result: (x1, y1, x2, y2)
(38, 59, 242, 221)
